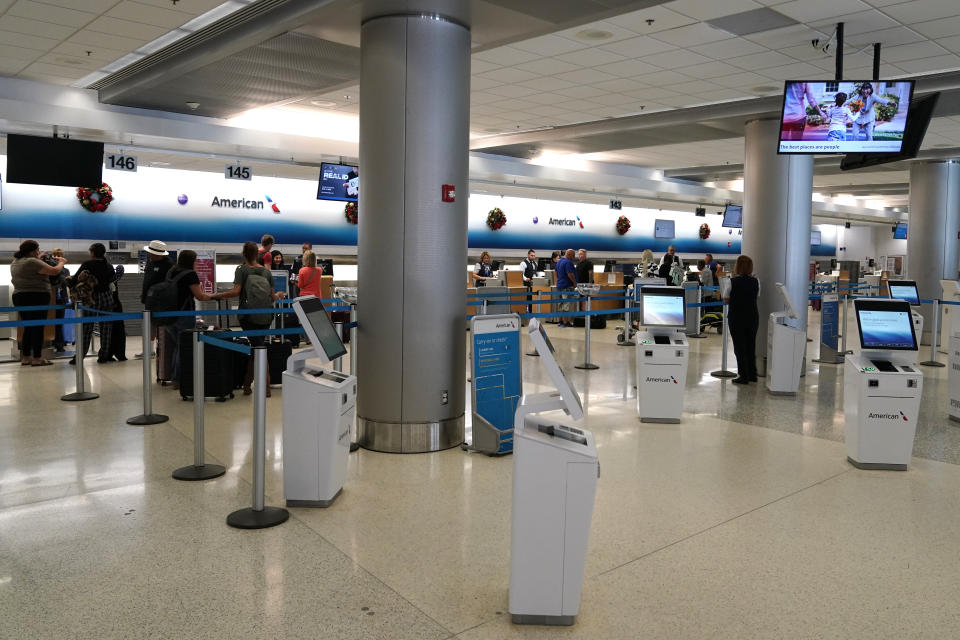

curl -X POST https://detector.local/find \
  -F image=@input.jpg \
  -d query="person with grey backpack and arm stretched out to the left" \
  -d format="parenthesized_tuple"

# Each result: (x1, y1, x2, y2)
(211, 242, 284, 398)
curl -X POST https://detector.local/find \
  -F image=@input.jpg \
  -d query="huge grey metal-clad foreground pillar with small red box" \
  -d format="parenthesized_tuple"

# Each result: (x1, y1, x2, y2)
(357, 5, 470, 453)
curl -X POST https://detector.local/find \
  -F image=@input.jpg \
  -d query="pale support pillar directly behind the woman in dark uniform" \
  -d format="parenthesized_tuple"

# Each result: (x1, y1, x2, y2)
(742, 119, 813, 375)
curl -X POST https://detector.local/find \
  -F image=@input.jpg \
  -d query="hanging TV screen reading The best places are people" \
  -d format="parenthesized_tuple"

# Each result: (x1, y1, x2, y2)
(777, 80, 913, 154)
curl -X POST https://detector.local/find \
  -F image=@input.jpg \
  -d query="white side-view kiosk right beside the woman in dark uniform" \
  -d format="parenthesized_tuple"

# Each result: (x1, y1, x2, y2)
(766, 282, 807, 395)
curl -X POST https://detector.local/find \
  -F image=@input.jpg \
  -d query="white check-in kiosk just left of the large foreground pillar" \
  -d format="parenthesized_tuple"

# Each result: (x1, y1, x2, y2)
(283, 296, 357, 507)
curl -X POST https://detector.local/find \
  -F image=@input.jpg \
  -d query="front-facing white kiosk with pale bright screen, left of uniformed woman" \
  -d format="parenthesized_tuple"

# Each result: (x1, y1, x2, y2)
(636, 287, 690, 422)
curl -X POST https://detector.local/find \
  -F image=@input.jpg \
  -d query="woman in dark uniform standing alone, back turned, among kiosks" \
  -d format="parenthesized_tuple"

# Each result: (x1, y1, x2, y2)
(723, 256, 760, 384)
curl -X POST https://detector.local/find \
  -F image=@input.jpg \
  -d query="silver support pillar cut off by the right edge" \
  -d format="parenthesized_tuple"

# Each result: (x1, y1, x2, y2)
(907, 160, 960, 344)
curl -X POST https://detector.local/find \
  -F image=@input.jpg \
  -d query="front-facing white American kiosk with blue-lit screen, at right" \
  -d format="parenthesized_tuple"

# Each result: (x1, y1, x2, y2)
(843, 298, 923, 470)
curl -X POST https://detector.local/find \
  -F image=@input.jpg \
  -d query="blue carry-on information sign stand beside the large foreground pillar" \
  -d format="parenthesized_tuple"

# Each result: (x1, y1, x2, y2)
(470, 314, 523, 454)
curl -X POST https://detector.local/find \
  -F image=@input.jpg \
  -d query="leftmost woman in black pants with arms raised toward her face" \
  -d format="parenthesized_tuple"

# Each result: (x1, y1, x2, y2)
(10, 240, 67, 367)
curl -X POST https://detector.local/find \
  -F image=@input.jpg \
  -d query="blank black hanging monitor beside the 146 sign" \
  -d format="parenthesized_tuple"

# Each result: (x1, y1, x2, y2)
(7, 133, 103, 187)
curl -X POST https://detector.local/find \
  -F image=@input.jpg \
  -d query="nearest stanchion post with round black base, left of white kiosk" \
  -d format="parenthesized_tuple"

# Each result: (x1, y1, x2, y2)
(227, 347, 290, 529)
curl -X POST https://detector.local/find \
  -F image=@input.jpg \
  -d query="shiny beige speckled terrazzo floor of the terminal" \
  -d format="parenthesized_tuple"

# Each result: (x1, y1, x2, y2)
(0, 308, 960, 639)
